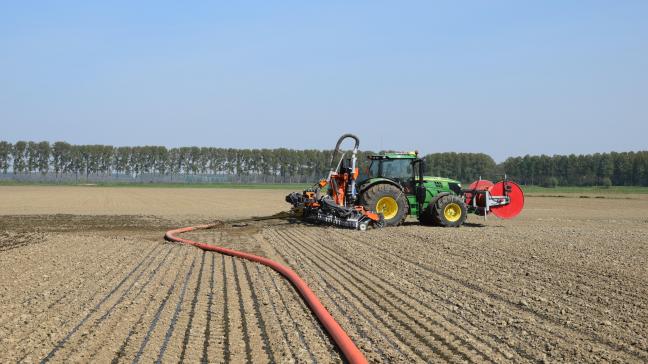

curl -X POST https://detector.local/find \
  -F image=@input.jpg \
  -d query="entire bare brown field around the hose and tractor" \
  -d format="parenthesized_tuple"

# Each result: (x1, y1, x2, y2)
(0, 187, 648, 362)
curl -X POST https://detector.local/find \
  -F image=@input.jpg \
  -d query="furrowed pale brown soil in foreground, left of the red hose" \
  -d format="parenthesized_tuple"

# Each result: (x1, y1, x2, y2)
(0, 220, 340, 363)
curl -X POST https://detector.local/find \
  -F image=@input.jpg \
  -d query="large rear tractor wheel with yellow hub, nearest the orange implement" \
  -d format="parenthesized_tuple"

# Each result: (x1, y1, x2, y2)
(360, 183, 409, 226)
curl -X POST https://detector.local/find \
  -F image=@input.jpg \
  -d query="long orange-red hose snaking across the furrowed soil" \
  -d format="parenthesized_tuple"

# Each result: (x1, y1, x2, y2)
(164, 224, 367, 363)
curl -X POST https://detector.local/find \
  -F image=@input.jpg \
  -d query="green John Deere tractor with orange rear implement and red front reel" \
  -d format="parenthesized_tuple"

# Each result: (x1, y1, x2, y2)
(286, 134, 524, 230)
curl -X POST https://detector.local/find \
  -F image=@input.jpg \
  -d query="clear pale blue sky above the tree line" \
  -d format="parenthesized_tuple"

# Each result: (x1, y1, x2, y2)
(0, 1, 648, 161)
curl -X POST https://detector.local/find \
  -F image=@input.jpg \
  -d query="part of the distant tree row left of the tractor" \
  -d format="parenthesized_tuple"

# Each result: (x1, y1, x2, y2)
(0, 141, 370, 182)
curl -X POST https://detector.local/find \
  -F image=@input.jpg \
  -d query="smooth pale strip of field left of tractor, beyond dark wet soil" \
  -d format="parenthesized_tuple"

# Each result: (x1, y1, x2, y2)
(0, 186, 290, 219)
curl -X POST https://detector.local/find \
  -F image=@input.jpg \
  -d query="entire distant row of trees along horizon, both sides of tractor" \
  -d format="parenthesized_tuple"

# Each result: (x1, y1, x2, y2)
(0, 141, 648, 187)
